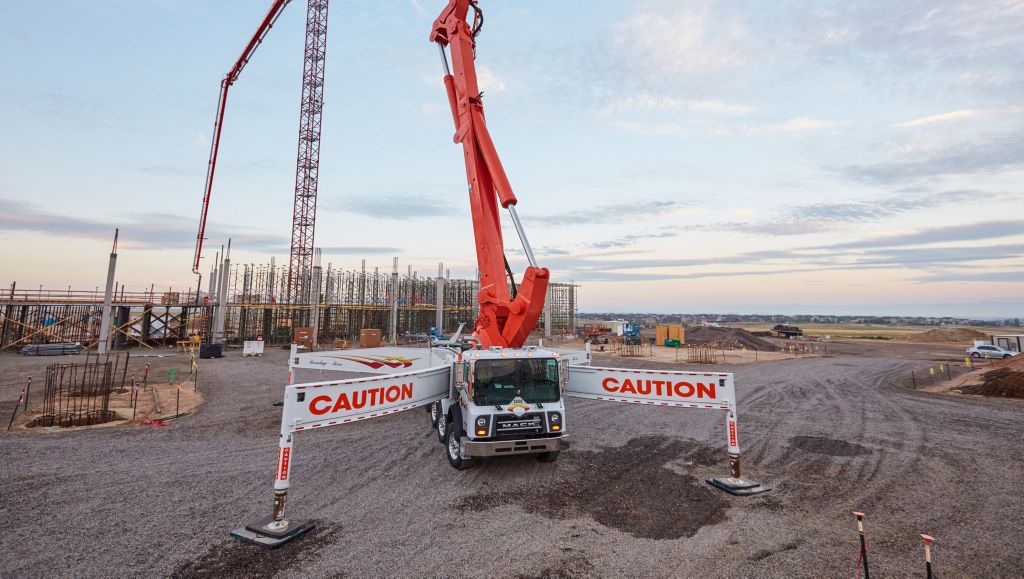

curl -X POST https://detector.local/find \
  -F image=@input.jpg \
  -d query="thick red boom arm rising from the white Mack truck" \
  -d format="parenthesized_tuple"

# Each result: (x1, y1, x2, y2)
(430, 0, 550, 347)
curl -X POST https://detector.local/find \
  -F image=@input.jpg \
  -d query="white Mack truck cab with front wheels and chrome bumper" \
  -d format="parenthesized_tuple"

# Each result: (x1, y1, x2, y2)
(429, 346, 569, 469)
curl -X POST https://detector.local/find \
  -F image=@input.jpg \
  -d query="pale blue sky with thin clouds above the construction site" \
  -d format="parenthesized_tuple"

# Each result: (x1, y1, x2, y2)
(0, 0, 1024, 316)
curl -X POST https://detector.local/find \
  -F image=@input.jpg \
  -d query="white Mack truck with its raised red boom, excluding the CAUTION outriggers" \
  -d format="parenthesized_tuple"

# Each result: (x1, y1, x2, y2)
(428, 0, 568, 469)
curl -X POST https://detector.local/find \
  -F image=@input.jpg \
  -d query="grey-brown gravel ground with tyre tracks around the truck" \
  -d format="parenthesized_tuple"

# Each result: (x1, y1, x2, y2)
(0, 346, 1024, 577)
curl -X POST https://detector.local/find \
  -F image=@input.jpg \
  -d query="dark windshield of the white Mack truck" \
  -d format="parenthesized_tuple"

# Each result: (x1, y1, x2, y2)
(473, 358, 561, 406)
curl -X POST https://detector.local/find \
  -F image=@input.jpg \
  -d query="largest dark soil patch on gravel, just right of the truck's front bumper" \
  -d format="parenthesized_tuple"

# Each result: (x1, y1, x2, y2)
(459, 437, 728, 539)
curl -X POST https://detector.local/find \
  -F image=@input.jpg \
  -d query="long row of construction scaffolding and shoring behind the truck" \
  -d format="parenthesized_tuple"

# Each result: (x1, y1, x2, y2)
(0, 261, 579, 350)
